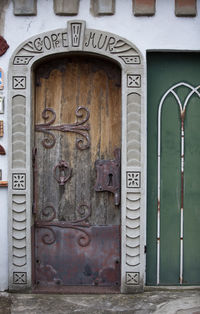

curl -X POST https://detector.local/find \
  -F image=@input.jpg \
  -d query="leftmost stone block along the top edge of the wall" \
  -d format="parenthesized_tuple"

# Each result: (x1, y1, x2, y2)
(13, 0, 37, 15)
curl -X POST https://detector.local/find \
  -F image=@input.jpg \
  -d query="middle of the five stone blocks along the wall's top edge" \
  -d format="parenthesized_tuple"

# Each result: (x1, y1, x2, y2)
(91, 0, 115, 16)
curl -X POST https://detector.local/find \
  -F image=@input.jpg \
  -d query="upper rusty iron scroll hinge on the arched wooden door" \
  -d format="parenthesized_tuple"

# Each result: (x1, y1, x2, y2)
(35, 106, 90, 150)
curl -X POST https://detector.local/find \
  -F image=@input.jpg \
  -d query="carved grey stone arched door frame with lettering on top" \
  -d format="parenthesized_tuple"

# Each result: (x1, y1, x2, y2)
(8, 20, 145, 293)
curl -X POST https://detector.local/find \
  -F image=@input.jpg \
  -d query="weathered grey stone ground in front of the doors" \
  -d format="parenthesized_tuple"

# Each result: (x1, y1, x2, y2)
(0, 290, 200, 314)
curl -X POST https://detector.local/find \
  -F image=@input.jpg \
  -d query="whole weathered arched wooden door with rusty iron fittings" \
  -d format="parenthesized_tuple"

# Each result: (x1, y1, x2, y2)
(33, 56, 121, 292)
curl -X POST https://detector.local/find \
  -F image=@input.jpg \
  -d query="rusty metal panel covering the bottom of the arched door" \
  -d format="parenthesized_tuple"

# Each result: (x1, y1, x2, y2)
(35, 222, 120, 288)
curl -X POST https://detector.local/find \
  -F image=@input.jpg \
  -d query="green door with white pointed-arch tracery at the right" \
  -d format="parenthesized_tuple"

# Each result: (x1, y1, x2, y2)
(147, 53, 200, 285)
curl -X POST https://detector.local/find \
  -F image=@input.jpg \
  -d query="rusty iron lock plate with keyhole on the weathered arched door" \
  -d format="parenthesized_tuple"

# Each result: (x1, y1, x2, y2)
(95, 148, 121, 205)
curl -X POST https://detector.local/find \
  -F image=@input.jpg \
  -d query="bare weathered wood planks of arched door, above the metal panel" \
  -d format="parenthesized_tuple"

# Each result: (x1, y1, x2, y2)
(35, 56, 121, 225)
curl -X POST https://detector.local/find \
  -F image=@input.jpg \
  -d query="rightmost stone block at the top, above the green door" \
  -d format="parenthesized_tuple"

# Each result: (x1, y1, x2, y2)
(175, 0, 197, 16)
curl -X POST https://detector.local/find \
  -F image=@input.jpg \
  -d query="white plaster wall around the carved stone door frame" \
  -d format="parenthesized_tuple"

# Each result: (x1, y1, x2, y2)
(0, 0, 200, 291)
